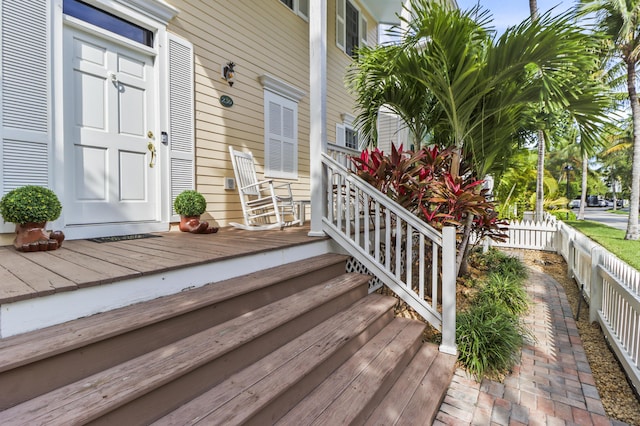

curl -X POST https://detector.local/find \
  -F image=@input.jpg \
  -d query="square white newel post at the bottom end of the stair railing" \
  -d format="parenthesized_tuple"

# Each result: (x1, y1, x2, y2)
(440, 226, 457, 355)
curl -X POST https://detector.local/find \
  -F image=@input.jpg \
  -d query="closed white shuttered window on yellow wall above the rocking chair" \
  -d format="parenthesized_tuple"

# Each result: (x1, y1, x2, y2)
(264, 90, 298, 179)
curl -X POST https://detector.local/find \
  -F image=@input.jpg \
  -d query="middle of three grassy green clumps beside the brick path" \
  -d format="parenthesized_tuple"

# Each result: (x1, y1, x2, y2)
(474, 273, 529, 316)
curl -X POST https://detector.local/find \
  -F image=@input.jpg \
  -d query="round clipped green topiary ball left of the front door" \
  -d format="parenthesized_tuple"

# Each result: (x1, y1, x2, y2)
(0, 185, 62, 224)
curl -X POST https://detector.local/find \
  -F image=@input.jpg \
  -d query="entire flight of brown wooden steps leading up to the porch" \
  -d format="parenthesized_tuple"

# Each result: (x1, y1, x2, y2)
(0, 251, 455, 426)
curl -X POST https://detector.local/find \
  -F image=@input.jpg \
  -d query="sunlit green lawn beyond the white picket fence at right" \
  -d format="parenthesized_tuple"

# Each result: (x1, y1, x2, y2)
(567, 220, 640, 270)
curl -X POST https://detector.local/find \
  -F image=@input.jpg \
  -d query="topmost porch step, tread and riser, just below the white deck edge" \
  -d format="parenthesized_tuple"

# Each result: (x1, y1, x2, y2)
(0, 254, 346, 410)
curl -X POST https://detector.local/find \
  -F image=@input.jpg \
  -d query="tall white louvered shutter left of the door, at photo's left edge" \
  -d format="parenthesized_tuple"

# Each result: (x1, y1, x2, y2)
(0, 0, 52, 232)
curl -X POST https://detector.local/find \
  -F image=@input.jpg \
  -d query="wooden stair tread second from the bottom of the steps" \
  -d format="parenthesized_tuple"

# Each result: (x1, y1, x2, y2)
(277, 318, 425, 425)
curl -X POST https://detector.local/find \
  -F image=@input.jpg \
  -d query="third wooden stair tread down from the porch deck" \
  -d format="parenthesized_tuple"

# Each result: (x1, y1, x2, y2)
(154, 294, 396, 426)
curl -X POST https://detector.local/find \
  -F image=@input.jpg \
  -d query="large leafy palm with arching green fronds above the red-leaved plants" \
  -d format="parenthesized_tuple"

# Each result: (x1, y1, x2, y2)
(347, 0, 608, 272)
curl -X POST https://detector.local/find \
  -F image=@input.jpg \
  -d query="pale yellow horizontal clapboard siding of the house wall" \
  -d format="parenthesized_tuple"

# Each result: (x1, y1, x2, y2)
(168, 0, 376, 226)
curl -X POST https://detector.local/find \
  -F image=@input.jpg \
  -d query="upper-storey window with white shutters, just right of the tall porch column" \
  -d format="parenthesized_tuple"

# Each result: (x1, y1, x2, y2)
(336, 0, 369, 56)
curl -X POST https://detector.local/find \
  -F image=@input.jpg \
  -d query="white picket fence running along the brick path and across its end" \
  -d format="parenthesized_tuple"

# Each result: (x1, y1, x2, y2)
(500, 217, 640, 391)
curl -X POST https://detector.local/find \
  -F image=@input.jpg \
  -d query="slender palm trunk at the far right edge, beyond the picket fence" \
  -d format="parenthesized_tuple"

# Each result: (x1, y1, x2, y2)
(624, 59, 640, 240)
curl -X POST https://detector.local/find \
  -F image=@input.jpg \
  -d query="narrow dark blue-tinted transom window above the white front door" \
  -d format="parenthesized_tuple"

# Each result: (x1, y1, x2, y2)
(62, 0, 153, 47)
